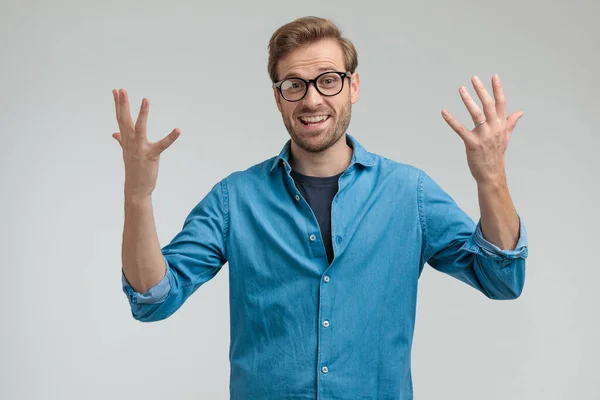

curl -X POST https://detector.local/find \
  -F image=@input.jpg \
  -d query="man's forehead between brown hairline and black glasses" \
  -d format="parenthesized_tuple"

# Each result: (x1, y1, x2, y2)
(277, 39, 344, 79)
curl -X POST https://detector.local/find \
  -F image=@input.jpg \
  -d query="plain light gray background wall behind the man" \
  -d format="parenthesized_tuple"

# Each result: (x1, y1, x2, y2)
(0, 0, 600, 400)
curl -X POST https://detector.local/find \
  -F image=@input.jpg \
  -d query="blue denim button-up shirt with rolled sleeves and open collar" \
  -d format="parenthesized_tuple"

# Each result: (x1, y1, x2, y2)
(122, 134, 527, 400)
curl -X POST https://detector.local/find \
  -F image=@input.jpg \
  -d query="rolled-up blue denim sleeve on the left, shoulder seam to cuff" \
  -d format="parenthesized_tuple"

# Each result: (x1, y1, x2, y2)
(121, 179, 229, 322)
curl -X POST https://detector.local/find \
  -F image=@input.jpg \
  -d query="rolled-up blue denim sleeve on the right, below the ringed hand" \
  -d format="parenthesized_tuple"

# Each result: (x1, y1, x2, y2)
(418, 171, 528, 300)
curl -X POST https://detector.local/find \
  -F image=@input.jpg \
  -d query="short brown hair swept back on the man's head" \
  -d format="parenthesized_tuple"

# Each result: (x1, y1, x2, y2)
(268, 17, 358, 82)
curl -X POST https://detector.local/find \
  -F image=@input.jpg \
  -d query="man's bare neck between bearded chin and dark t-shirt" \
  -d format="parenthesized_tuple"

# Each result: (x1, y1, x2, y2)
(289, 134, 352, 177)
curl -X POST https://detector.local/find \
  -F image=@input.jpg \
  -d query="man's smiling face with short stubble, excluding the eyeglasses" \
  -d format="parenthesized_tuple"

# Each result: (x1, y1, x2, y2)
(273, 40, 359, 153)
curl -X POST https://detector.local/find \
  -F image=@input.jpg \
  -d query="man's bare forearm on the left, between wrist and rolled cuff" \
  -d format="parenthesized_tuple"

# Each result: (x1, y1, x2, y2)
(121, 195, 166, 293)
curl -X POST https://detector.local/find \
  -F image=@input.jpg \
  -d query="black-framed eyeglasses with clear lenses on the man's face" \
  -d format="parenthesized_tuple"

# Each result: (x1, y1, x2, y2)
(273, 71, 352, 101)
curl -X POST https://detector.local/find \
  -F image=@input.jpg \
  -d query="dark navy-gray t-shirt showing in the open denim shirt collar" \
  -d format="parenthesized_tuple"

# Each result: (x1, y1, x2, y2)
(290, 169, 343, 264)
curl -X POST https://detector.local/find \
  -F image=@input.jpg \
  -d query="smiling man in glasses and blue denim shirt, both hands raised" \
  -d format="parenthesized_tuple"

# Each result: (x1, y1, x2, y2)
(113, 17, 527, 400)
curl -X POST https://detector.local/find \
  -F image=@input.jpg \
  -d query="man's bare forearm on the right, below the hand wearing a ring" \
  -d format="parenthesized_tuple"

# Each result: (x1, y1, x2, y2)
(477, 177, 519, 250)
